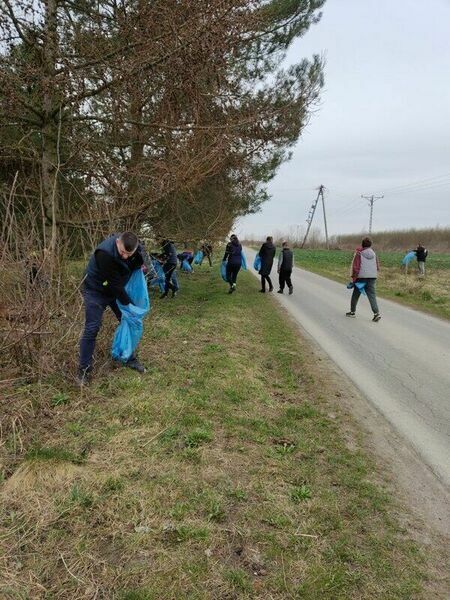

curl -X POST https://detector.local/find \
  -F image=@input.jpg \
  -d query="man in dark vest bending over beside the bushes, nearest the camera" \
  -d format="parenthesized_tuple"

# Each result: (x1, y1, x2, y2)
(77, 231, 145, 385)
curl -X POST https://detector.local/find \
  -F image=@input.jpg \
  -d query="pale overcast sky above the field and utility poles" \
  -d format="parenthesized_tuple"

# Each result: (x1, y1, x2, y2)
(236, 0, 450, 236)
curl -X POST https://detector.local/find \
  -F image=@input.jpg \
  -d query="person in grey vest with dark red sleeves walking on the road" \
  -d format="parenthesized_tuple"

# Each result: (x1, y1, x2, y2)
(346, 237, 381, 323)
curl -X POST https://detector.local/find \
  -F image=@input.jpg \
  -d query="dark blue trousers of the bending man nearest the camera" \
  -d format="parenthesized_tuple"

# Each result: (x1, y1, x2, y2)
(80, 288, 122, 370)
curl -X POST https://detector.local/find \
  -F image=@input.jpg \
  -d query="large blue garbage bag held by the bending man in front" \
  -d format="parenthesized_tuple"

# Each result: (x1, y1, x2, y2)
(111, 269, 150, 362)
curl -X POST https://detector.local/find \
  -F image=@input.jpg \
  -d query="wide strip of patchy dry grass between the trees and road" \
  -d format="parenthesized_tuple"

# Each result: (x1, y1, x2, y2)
(0, 267, 432, 600)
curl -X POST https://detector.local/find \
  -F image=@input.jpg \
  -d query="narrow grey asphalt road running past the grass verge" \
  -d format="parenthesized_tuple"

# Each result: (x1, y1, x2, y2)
(246, 248, 450, 486)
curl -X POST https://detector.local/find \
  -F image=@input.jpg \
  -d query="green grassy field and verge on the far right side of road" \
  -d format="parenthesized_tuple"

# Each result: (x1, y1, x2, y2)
(295, 249, 450, 319)
